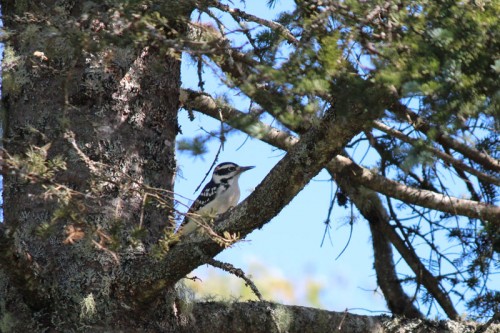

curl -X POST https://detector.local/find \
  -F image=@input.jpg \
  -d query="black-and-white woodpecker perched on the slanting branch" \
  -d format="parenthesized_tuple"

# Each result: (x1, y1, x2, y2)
(180, 162, 254, 234)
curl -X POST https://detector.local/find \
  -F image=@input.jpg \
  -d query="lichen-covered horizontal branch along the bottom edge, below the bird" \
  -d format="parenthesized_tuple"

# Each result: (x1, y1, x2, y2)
(179, 302, 494, 333)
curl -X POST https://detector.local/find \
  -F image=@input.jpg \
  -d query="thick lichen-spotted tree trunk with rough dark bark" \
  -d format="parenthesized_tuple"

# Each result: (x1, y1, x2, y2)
(0, 1, 185, 332)
